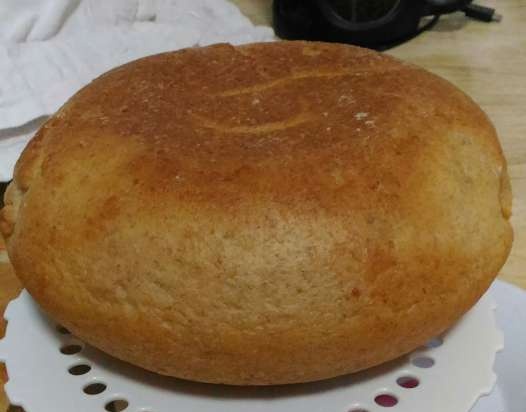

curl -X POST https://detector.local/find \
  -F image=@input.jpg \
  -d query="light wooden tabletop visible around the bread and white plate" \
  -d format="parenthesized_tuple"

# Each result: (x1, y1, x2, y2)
(0, 0, 526, 412)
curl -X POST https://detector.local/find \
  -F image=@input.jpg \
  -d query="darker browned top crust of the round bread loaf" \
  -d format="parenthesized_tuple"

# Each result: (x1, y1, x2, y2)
(7, 42, 512, 219)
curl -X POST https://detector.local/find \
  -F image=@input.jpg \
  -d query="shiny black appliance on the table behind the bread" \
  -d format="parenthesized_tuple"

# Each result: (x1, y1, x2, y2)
(273, 0, 501, 50)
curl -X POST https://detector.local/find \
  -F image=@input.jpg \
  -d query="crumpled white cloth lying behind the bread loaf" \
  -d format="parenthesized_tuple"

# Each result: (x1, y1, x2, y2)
(0, 0, 274, 181)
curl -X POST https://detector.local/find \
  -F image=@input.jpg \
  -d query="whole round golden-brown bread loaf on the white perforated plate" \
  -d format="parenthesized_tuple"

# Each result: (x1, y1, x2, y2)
(1, 42, 512, 385)
